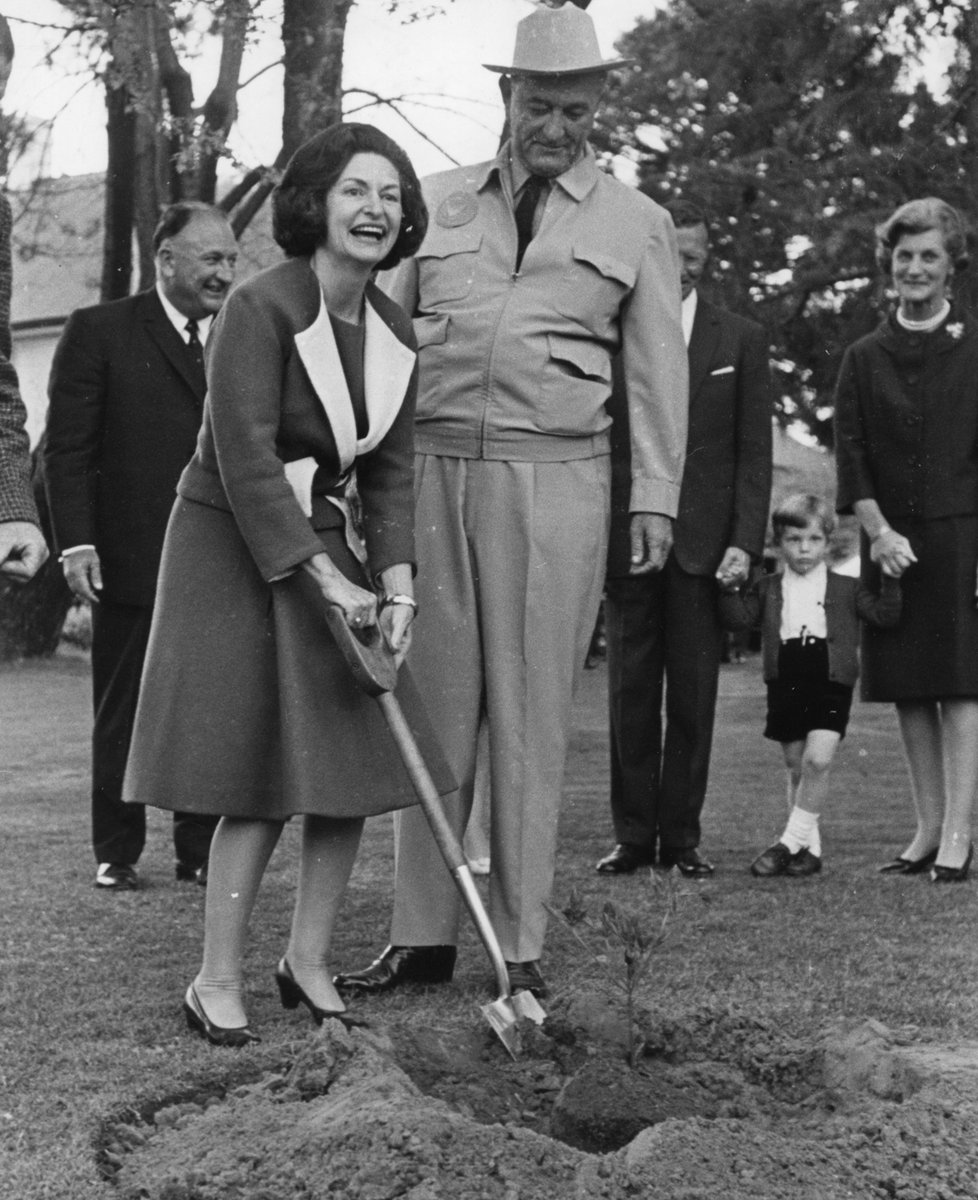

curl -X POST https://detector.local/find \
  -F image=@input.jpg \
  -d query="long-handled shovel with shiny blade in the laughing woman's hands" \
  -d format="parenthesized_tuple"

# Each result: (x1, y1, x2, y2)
(326, 605, 547, 1058)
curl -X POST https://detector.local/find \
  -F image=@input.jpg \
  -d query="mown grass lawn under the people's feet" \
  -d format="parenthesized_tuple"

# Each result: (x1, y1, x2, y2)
(0, 658, 978, 1200)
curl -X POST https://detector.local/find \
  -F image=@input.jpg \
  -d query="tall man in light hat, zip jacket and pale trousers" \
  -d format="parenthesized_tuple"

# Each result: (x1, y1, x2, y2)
(337, 4, 688, 995)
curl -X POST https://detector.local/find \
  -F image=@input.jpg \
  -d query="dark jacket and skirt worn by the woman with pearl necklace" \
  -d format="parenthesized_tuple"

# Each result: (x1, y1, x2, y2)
(835, 312, 978, 701)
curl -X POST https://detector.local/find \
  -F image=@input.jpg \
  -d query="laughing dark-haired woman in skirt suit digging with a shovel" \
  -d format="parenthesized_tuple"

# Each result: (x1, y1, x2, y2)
(126, 125, 454, 1046)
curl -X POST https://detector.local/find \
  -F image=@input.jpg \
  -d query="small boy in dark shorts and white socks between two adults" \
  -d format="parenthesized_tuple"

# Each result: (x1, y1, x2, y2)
(720, 493, 901, 876)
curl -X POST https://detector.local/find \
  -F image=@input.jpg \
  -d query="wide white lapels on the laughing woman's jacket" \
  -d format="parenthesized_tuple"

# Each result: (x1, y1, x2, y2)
(295, 293, 415, 472)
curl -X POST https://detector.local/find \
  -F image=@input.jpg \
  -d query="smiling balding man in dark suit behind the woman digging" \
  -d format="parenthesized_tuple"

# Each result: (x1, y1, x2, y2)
(44, 202, 238, 890)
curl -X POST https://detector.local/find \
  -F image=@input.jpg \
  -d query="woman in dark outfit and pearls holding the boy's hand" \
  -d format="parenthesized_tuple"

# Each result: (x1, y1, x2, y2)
(835, 198, 978, 883)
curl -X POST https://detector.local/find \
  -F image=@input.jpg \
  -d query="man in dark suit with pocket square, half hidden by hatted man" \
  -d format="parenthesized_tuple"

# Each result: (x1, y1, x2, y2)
(596, 202, 773, 878)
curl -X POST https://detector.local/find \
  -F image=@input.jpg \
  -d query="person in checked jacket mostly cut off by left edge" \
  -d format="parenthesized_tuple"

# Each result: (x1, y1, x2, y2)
(0, 17, 48, 583)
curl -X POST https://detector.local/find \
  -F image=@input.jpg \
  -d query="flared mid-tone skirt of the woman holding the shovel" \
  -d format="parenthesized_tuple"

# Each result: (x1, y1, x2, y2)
(124, 498, 456, 821)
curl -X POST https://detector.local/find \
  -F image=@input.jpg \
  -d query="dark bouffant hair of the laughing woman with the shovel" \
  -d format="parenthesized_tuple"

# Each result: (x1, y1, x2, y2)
(271, 122, 428, 271)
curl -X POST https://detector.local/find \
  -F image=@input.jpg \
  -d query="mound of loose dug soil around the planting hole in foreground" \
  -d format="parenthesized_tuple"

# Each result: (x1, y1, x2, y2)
(100, 1001, 978, 1200)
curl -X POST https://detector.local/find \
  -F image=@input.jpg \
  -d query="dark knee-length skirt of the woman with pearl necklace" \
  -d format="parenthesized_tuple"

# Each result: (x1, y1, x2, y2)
(862, 516, 978, 701)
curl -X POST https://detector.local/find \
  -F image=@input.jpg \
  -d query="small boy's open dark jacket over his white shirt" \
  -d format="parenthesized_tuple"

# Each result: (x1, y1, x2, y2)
(720, 571, 902, 688)
